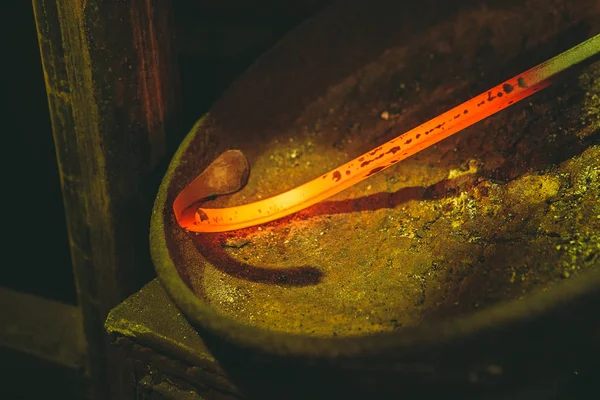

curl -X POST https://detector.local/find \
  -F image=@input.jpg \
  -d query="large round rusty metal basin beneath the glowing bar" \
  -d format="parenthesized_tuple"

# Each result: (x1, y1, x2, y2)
(150, 0, 600, 398)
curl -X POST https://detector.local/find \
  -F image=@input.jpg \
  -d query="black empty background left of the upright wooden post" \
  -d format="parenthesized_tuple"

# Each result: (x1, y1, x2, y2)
(0, 1, 77, 304)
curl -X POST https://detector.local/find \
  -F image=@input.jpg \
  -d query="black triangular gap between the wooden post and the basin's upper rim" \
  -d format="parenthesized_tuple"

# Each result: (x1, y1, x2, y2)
(174, 0, 332, 129)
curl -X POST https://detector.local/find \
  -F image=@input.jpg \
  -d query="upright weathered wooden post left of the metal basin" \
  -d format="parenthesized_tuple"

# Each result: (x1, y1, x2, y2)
(27, 0, 181, 399)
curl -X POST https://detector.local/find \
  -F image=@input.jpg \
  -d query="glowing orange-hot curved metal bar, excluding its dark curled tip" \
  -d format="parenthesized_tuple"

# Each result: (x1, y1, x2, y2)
(174, 35, 600, 232)
